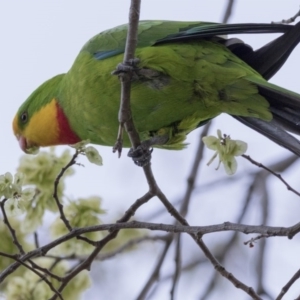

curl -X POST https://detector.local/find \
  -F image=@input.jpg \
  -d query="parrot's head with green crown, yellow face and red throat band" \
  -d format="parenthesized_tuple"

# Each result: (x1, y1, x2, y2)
(13, 74, 80, 154)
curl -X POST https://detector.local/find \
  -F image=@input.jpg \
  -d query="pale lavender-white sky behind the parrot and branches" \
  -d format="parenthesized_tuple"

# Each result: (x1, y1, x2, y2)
(0, 0, 300, 300)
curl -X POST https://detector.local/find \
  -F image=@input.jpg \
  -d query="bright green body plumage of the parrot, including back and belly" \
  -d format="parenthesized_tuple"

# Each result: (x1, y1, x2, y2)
(16, 21, 300, 155)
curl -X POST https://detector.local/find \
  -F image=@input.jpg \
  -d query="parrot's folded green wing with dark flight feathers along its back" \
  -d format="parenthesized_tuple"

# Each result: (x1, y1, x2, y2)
(81, 21, 292, 60)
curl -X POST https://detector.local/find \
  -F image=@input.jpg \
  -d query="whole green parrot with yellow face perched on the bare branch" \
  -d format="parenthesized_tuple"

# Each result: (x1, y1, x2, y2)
(13, 21, 300, 165)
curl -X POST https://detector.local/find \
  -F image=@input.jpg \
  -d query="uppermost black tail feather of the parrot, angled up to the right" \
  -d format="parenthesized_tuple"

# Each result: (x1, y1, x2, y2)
(240, 22, 300, 80)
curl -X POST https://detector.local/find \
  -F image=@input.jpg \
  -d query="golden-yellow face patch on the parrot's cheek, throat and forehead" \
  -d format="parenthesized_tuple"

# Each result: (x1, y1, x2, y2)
(13, 99, 59, 147)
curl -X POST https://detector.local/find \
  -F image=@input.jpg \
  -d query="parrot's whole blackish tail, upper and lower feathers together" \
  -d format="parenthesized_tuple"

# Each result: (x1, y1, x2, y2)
(234, 22, 300, 156)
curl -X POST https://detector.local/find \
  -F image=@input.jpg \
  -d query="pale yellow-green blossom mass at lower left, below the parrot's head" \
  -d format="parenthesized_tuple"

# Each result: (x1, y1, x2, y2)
(0, 143, 104, 300)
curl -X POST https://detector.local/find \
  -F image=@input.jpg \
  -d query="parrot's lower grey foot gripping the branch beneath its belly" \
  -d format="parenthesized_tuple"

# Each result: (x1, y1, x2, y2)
(127, 135, 169, 167)
